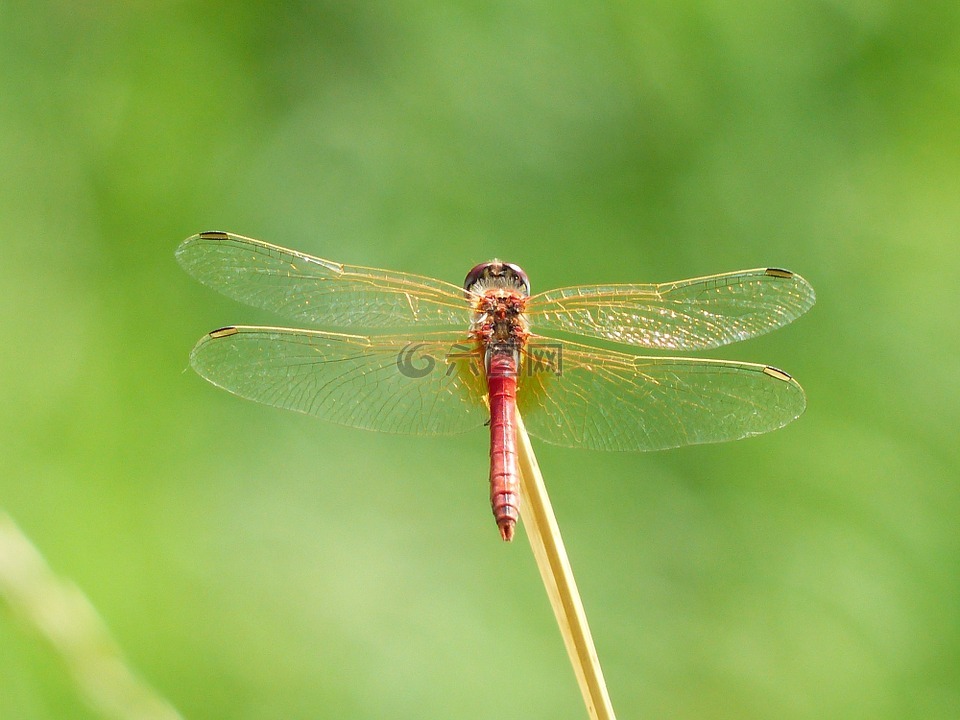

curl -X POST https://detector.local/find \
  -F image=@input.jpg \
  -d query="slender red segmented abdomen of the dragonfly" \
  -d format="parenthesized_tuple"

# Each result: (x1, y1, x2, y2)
(487, 352, 520, 542)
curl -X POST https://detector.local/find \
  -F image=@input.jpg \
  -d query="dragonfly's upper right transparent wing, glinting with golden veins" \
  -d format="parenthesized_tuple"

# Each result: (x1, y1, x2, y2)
(527, 268, 815, 350)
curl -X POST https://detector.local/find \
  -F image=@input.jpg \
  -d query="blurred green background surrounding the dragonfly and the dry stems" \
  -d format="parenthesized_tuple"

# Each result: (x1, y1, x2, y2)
(0, 0, 960, 720)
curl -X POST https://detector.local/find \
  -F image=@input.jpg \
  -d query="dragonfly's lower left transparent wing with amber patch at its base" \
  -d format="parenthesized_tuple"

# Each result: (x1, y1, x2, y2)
(190, 326, 488, 435)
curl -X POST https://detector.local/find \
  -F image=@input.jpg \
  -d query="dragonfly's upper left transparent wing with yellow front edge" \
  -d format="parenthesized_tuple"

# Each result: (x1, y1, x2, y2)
(176, 232, 470, 329)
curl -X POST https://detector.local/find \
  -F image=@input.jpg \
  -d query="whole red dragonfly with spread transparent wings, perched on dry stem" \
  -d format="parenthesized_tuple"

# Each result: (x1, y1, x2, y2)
(176, 231, 815, 541)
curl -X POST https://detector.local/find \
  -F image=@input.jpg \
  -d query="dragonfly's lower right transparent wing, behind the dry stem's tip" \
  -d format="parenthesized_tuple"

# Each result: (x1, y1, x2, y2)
(517, 338, 806, 450)
